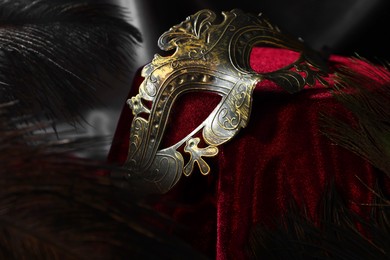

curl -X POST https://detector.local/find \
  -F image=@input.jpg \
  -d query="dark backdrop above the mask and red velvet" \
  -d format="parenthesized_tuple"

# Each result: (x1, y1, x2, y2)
(132, 0, 390, 62)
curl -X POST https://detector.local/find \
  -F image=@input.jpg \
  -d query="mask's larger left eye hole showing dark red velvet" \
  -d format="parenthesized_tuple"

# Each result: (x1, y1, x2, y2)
(159, 92, 222, 149)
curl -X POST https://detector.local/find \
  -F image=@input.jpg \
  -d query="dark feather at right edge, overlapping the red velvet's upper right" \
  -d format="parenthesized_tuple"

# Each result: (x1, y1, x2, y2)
(320, 58, 390, 177)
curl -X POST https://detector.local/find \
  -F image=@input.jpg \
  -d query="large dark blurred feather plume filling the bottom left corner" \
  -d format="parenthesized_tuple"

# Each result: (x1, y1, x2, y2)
(0, 103, 206, 259)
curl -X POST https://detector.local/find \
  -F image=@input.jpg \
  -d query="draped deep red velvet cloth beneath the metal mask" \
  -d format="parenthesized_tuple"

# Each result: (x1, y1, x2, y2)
(109, 47, 386, 260)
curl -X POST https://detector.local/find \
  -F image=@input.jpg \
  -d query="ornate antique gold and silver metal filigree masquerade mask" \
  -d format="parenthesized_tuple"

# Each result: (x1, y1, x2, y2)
(111, 9, 325, 193)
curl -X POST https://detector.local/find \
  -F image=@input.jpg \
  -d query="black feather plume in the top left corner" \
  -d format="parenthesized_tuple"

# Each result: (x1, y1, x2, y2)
(0, 0, 142, 122)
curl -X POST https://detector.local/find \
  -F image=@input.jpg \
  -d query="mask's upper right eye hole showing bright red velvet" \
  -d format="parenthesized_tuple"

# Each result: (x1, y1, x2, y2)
(249, 46, 300, 73)
